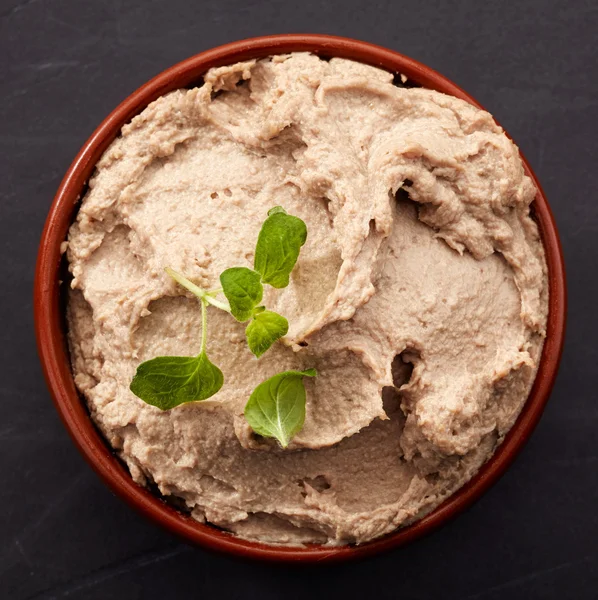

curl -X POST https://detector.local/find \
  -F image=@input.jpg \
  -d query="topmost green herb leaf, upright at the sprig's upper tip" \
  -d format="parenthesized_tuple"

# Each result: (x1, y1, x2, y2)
(253, 206, 307, 288)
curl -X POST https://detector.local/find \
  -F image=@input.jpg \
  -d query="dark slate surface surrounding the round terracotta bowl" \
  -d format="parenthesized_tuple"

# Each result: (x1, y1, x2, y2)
(0, 0, 598, 600)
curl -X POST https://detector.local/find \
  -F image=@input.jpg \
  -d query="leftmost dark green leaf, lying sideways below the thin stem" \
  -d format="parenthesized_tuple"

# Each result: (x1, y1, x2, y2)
(130, 353, 224, 410)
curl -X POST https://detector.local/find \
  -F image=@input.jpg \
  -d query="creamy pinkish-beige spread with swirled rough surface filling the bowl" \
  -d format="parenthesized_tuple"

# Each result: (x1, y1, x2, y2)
(68, 54, 548, 544)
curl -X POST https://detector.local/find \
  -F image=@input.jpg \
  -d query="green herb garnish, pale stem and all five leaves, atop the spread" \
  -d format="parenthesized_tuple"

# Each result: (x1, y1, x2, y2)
(130, 206, 316, 448)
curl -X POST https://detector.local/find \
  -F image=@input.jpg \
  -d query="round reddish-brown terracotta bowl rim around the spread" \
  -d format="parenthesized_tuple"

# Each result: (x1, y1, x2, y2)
(34, 35, 566, 562)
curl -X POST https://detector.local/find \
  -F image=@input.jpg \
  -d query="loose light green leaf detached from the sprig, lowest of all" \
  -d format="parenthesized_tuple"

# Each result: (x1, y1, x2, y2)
(245, 369, 317, 448)
